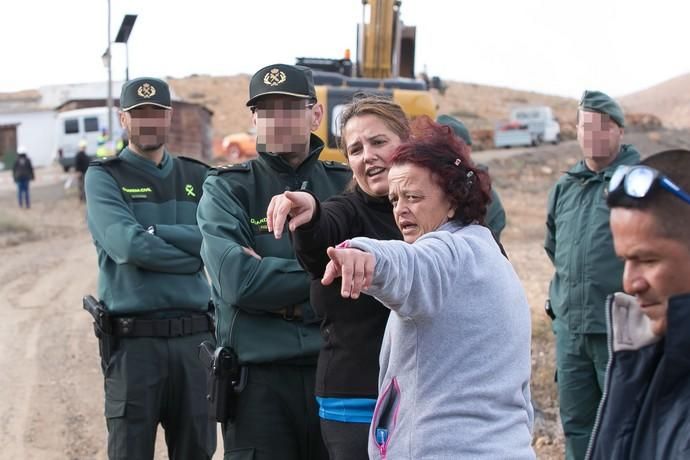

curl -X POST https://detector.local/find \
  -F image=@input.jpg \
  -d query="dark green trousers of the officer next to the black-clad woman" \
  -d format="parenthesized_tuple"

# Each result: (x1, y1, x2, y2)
(223, 363, 328, 460)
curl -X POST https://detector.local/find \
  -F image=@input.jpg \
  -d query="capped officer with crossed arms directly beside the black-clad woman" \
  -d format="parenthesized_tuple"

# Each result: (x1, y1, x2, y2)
(198, 64, 351, 460)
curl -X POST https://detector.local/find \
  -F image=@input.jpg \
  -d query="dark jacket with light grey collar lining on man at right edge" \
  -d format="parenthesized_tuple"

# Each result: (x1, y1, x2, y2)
(587, 294, 690, 460)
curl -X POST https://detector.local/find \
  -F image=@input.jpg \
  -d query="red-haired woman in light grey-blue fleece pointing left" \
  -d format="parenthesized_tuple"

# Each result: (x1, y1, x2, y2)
(322, 118, 534, 460)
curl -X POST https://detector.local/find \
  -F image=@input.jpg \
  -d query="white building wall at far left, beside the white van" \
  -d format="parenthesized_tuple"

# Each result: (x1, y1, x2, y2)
(0, 110, 56, 166)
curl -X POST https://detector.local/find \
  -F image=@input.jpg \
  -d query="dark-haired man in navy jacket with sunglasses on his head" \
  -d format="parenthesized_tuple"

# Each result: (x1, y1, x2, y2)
(588, 150, 690, 460)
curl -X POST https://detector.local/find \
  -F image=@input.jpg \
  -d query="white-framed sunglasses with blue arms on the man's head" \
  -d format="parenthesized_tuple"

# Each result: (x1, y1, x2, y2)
(608, 165, 690, 204)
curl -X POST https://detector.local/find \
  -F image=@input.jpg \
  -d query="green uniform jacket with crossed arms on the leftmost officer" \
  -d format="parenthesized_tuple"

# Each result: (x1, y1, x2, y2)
(85, 148, 210, 316)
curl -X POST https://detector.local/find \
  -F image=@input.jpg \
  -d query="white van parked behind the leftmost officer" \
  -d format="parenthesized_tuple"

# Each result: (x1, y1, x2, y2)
(55, 107, 122, 171)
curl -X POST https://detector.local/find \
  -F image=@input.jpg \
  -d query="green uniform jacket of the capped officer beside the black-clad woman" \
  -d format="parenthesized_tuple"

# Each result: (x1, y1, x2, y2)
(198, 135, 351, 363)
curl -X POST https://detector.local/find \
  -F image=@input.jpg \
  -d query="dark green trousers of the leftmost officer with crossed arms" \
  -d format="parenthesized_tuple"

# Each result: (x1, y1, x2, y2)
(104, 332, 216, 460)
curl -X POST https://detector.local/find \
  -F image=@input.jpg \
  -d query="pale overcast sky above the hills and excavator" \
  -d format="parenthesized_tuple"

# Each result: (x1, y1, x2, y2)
(0, 0, 690, 98)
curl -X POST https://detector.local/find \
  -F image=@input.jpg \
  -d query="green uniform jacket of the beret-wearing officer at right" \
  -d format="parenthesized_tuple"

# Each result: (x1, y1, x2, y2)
(544, 145, 640, 334)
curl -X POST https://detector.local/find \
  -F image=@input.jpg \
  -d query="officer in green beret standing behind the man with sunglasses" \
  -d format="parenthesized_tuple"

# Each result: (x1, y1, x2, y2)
(544, 91, 640, 460)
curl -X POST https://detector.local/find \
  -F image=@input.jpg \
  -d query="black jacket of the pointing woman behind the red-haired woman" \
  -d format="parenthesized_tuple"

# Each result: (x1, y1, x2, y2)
(292, 187, 402, 398)
